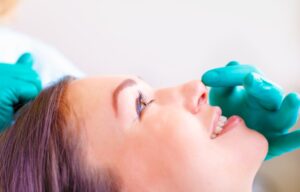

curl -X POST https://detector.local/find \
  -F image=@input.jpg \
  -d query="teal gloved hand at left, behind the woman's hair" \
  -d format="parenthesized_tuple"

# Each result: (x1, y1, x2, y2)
(0, 53, 42, 131)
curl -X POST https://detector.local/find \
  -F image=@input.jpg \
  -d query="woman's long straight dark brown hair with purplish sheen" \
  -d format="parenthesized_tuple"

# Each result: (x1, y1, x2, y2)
(0, 77, 119, 192)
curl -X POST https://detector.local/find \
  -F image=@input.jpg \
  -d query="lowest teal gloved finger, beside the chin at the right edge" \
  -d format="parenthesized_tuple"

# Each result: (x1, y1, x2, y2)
(265, 130, 300, 160)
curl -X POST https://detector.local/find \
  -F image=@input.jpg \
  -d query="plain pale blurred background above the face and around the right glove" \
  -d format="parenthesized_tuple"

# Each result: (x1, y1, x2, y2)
(4, 0, 300, 192)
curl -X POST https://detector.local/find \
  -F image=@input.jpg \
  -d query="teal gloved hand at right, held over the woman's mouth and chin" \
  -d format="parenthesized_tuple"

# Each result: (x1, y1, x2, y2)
(202, 61, 300, 160)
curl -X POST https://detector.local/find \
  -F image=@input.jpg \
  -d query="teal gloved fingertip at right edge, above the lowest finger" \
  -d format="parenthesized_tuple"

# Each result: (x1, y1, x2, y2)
(269, 93, 300, 130)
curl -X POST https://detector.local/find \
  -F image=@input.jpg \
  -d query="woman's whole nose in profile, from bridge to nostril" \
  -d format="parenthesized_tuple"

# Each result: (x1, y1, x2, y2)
(155, 80, 207, 113)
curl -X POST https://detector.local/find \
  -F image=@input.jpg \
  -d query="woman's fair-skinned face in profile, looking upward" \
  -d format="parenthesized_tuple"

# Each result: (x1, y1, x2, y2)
(68, 76, 267, 192)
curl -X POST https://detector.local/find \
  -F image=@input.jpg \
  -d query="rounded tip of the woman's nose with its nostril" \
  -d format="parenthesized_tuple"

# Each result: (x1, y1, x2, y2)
(182, 80, 207, 113)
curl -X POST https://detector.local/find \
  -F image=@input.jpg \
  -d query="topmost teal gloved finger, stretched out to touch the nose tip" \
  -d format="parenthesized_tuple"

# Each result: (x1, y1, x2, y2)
(202, 62, 259, 87)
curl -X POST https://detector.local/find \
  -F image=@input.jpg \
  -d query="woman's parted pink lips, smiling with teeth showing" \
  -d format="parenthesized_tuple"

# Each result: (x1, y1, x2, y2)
(210, 107, 241, 139)
